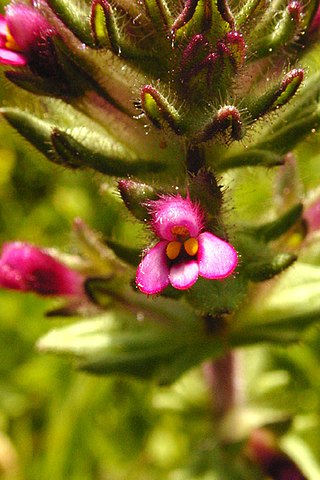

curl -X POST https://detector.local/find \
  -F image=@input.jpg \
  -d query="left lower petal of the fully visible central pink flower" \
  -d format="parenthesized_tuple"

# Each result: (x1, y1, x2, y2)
(136, 241, 169, 295)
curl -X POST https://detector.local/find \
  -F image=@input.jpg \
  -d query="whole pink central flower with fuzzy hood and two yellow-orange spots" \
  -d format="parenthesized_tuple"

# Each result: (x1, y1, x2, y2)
(136, 195, 238, 295)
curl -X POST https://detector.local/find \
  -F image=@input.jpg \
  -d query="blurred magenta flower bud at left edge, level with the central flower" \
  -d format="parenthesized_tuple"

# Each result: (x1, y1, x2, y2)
(0, 242, 83, 295)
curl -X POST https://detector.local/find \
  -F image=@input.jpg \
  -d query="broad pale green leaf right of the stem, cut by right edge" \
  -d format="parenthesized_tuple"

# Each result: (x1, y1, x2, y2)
(230, 262, 320, 345)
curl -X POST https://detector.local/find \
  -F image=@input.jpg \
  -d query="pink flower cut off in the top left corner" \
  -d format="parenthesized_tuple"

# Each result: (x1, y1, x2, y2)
(0, 3, 55, 66)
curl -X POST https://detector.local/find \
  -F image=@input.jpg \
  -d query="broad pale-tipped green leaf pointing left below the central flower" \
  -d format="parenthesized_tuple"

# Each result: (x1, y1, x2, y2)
(37, 312, 222, 384)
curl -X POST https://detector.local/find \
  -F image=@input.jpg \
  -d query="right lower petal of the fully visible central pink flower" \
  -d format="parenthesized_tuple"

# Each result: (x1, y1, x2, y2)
(198, 232, 238, 279)
